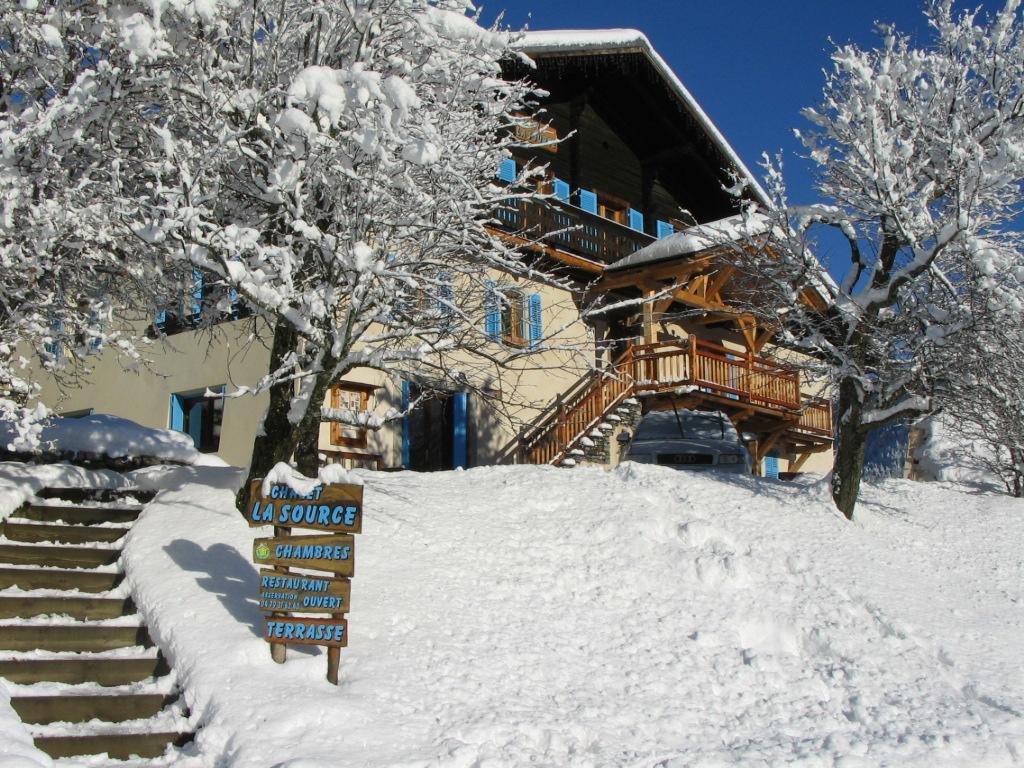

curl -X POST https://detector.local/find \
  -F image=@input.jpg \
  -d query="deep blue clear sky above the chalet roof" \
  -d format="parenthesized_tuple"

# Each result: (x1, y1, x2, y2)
(483, 0, 1001, 272)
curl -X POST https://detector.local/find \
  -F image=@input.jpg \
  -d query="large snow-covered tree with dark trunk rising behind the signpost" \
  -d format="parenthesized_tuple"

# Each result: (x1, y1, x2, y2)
(0, 0, 573, 487)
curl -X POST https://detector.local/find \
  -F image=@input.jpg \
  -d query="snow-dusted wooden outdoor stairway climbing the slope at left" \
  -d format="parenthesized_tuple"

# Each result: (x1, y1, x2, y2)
(0, 488, 191, 760)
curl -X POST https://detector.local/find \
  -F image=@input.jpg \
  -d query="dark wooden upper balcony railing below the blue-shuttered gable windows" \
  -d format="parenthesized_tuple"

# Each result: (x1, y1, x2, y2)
(497, 198, 655, 264)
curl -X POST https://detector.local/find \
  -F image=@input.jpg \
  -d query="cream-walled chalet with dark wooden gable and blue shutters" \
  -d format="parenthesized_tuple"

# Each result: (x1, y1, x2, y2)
(37, 30, 833, 474)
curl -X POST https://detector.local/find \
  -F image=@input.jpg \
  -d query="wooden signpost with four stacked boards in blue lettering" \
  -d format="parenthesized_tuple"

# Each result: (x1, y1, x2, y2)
(246, 479, 362, 685)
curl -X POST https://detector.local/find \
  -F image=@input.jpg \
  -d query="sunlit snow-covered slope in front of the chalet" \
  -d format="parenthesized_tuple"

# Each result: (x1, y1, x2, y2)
(0, 465, 1024, 768)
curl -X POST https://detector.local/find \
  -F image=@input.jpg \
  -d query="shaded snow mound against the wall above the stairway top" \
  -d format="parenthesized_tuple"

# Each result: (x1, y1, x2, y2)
(0, 414, 210, 464)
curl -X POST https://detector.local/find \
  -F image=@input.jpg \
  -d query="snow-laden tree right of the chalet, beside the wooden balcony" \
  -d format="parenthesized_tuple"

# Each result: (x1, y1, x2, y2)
(720, 0, 1024, 517)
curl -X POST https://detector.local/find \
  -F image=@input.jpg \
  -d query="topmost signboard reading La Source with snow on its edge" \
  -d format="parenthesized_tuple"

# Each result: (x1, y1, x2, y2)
(246, 479, 362, 534)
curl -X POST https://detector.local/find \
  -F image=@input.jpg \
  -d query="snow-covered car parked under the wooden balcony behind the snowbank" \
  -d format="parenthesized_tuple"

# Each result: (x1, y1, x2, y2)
(618, 409, 751, 474)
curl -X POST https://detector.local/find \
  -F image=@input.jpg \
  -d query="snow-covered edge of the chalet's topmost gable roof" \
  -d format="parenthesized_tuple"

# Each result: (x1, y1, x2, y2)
(517, 30, 771, 206)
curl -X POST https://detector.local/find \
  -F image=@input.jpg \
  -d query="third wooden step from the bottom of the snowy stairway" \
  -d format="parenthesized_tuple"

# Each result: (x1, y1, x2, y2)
(0, 656, 170, 685)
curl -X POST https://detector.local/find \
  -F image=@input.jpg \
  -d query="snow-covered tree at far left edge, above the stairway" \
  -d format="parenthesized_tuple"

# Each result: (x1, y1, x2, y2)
(0, 7, 180, 450)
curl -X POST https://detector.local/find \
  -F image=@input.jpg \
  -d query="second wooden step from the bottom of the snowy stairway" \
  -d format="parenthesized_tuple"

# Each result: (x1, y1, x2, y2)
(10, 693, 175, 724)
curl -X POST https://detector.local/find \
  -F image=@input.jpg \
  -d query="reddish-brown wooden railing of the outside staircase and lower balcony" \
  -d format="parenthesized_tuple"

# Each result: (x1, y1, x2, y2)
(512, 337, 831, 464)
